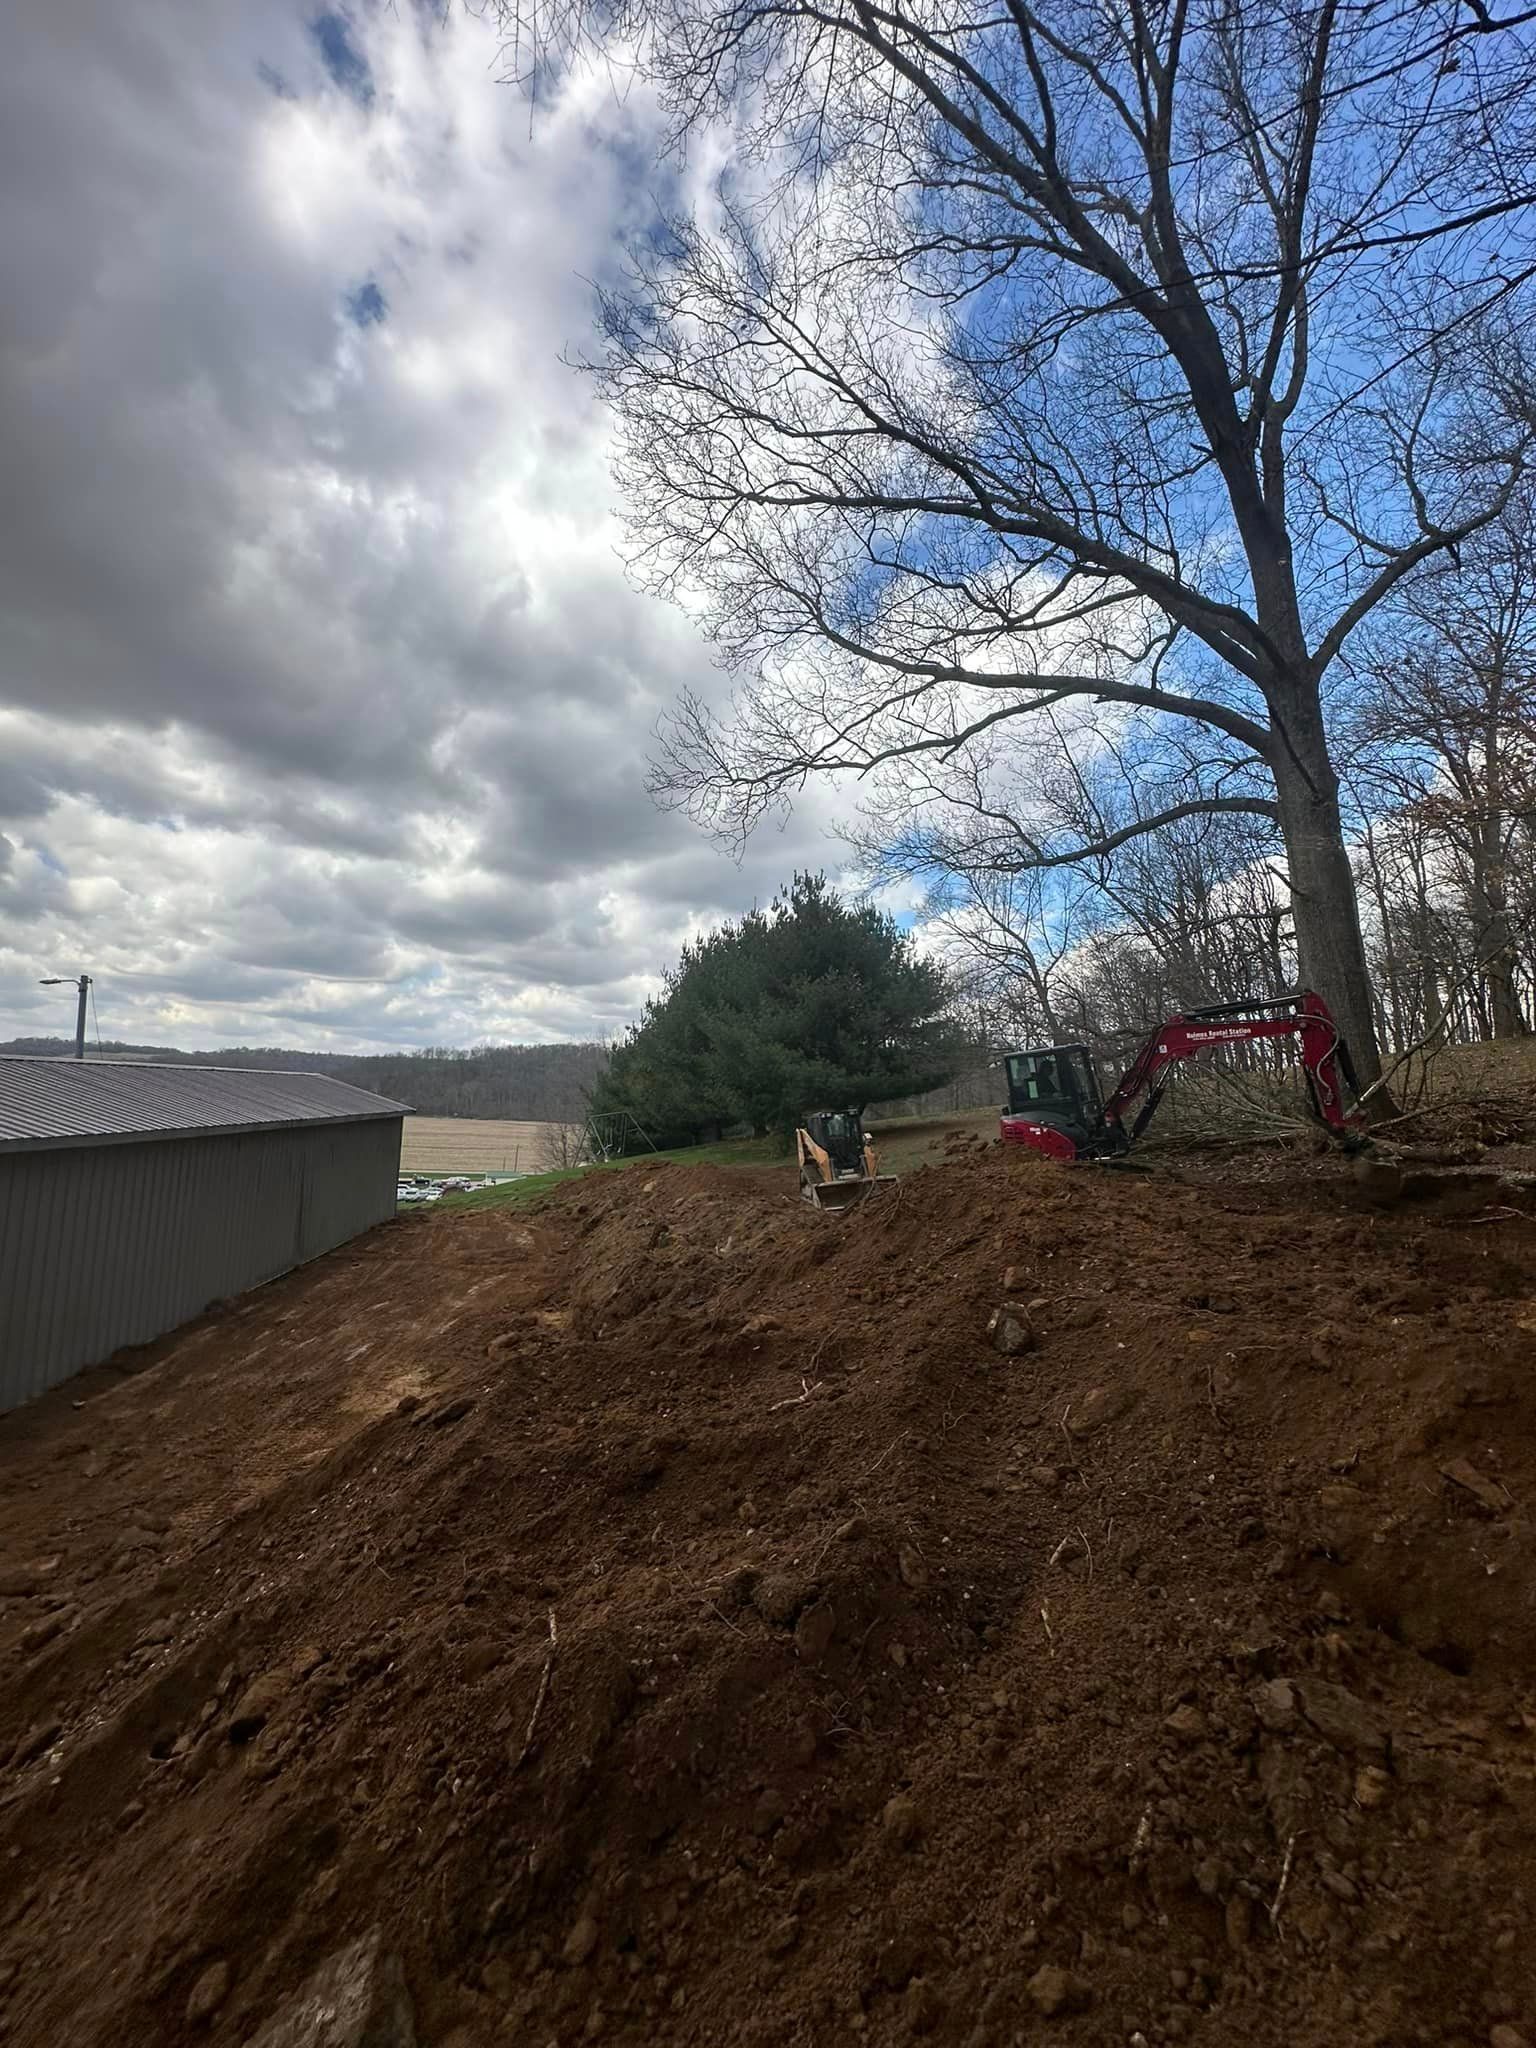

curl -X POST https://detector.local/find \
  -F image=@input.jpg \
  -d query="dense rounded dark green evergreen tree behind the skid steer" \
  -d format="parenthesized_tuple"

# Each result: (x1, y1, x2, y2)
(592, 874, 954, 1145)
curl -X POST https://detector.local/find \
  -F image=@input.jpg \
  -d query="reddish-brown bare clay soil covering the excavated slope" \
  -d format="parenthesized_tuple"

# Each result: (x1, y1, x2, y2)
(0, 1149, 1536, 2048)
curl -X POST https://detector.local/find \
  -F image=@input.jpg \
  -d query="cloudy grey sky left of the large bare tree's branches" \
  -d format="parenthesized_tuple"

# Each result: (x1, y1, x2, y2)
(0, 0, 856, 1051)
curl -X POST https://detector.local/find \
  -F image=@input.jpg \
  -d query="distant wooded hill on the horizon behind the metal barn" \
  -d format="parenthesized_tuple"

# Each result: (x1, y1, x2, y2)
(0, 1038, 608, 1122)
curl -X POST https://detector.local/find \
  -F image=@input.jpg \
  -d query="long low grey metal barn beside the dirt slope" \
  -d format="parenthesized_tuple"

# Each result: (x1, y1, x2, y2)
(0, 1057, 406, 1411)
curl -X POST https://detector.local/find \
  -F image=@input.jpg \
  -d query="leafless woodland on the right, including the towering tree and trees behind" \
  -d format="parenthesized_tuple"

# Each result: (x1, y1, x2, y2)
(500, 0, 1536, 1079)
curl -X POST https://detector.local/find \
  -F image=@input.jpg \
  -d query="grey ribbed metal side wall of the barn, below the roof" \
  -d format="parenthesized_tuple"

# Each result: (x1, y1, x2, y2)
(0, 1118, 401, 1411)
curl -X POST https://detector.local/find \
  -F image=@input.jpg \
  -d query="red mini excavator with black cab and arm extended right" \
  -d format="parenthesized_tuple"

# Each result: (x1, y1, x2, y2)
(1001, 989, 1358, 1159)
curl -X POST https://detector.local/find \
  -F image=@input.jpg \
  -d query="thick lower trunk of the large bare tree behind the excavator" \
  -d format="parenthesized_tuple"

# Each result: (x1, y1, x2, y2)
(1274, 692, 1384, 1108)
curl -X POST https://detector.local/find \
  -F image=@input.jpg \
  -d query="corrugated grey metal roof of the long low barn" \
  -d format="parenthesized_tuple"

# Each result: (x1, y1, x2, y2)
(0, 1053, 408, 1153)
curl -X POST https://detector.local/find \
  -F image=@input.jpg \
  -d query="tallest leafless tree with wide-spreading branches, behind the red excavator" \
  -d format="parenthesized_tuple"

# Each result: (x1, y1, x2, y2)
(489, 0, 1532, 1075)
